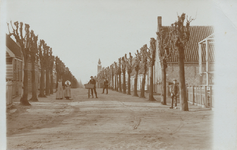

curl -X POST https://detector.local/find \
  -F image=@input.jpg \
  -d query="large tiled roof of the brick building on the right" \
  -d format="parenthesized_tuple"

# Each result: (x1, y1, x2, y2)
(164, 26, 214, 63)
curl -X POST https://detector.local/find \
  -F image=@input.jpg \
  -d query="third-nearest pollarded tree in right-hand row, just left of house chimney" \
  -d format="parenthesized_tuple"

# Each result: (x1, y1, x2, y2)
(147, 38, 156, 101)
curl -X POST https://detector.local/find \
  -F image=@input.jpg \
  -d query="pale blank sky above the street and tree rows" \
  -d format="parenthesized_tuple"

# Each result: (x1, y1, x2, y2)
(6, 0, 213, 83)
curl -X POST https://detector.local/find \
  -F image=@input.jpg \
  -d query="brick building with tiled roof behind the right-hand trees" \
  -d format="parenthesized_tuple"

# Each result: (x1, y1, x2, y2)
(154, 20, 214, 93)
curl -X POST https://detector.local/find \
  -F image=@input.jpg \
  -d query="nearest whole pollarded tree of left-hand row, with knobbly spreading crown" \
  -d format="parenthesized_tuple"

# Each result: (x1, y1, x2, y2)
(9, 21, 31, 105)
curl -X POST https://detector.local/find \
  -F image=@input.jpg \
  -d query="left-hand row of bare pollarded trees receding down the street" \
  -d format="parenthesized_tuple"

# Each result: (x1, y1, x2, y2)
(8, 21, 77, 105)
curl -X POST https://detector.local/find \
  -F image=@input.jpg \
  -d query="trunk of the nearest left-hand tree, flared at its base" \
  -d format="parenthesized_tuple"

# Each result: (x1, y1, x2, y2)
(20, 57, 31, 106)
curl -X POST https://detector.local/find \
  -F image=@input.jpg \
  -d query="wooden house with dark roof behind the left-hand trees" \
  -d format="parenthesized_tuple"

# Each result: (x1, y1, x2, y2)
(6, 35, 40, 96)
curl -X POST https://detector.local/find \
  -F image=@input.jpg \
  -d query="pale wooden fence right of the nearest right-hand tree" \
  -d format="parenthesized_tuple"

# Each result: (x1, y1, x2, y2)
(187, 86, 214, 108)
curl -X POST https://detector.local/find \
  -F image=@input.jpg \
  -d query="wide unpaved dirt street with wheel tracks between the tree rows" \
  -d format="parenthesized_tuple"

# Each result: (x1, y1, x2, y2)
(7, 89, 213, 150)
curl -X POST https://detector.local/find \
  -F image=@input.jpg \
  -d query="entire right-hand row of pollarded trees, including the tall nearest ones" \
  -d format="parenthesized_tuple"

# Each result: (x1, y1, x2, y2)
(98, 13, 193, 111)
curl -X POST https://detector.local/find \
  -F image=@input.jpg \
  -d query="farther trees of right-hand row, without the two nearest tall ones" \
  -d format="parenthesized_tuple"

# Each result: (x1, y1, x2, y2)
(97, 38, 156, 101)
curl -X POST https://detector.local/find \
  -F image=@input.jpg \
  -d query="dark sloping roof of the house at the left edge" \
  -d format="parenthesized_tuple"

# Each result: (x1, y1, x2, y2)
(6, 35, 22, 59)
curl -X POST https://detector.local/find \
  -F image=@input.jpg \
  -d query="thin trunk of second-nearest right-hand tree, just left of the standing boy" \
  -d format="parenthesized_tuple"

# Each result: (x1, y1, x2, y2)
(161, 60, 166, 105)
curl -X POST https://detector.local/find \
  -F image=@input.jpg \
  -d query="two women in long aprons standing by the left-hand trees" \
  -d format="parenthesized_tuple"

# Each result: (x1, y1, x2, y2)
(56, 79, 71, 99)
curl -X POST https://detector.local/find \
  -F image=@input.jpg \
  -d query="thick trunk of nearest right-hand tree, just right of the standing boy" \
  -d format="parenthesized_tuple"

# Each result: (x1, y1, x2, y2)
(178, 47, 188, 111)
